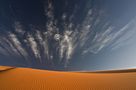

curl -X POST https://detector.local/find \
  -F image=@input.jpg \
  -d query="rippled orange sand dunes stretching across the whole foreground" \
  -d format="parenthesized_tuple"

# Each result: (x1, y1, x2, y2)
(0, 66, 136, 90)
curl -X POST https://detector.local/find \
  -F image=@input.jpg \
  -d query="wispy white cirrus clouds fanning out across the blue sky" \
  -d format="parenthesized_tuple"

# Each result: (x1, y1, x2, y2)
(0, 2, 136, 67)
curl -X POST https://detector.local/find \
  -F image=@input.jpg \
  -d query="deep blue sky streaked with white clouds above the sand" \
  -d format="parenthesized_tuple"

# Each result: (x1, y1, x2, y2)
(0, 0, 136, 71)
